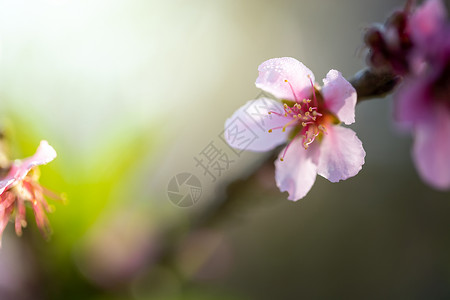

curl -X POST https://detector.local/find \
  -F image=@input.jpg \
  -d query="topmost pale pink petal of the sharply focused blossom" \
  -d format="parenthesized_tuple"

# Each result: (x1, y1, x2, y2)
(255, 57, 314, 101)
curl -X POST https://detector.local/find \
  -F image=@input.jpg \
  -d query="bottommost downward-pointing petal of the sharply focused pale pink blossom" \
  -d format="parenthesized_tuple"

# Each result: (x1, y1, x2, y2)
(275, 138, 319, 201)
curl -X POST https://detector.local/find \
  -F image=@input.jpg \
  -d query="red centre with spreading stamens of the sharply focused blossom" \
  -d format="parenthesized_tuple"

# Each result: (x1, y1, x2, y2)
(268, 76, 326, 161)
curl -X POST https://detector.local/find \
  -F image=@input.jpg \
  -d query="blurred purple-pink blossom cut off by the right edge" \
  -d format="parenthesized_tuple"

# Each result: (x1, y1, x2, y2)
(395, 0, 450, 189)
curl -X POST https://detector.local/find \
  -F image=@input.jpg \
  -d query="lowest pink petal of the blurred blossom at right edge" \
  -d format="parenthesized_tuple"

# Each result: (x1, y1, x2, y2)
(413, 105, 450, 189)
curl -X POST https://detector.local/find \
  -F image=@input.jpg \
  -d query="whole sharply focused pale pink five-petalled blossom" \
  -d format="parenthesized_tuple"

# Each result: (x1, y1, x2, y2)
(225, 57, 365, 201)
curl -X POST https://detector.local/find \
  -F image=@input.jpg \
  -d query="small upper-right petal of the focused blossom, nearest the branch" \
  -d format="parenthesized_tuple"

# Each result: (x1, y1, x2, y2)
(322, 70, 357, 125)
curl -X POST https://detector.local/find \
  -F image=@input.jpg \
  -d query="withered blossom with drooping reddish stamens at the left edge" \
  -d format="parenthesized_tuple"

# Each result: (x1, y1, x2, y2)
(0, 141, 59, 242)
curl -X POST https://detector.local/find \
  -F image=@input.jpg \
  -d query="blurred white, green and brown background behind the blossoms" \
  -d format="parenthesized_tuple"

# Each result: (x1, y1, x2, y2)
(0, 0, 450, 300)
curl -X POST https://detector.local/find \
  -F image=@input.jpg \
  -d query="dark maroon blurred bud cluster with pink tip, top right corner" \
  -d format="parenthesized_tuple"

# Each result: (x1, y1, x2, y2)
(364, 0, 447, 76)
